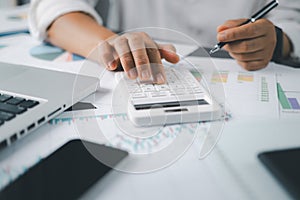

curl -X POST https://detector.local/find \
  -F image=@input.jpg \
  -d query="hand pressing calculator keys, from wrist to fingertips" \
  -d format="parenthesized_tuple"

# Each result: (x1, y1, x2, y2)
(97, 32, 179, 84)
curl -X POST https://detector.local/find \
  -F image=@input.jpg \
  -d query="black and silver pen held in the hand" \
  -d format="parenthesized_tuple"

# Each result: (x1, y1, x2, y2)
(209, 0, 278, 54)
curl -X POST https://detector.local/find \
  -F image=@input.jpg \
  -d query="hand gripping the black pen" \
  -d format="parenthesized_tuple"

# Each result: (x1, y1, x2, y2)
(217, 19, 276, 70)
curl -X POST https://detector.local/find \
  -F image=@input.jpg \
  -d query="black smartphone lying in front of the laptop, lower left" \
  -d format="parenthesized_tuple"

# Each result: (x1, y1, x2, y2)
(0, 140, 128, 200)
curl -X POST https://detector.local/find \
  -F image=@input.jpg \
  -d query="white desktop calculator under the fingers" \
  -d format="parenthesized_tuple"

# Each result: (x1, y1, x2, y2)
(116, 67, 223, 126)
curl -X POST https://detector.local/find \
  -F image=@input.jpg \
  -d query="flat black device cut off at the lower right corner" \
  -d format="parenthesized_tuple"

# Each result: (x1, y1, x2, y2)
(258, 148, 300, 199)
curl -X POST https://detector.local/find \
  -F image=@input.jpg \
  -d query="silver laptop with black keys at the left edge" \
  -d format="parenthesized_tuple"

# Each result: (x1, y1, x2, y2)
(0, 62, 98, 150)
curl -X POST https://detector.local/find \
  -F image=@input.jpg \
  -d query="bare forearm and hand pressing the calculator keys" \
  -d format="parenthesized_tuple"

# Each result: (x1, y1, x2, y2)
(47, 12, 179, 84)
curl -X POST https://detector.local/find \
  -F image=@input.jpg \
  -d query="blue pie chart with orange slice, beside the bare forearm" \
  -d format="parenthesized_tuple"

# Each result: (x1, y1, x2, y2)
(30, 44, 84, 62)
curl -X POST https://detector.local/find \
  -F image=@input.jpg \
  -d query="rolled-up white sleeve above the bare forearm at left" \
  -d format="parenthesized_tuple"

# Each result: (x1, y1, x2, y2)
(28, 0, 102, 40)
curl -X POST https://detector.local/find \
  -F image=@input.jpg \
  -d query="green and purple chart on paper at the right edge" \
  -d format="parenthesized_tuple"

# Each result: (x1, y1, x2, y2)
(277, 83, 300, 111)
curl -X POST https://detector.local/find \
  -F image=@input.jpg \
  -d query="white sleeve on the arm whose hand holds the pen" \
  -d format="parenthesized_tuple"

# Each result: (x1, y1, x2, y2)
(269, 0, 300, 58)
